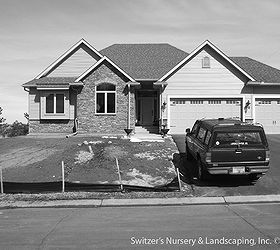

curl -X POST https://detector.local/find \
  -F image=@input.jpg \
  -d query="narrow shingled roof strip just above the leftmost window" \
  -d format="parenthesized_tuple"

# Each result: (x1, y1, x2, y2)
(22, 76, 78, 87)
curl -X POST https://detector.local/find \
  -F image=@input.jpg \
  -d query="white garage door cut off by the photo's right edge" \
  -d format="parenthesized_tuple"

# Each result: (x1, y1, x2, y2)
(255, 98, 280, 134)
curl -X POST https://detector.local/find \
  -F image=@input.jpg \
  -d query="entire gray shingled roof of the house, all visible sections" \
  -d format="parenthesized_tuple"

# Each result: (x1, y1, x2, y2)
(22, 43, 280, 87)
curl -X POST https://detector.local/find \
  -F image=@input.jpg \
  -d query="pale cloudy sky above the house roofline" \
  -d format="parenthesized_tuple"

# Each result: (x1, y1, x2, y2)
(0, 0, 280, 123)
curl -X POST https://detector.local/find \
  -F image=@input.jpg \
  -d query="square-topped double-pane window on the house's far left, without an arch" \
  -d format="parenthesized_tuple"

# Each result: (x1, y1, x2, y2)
(46, 94, 64, 114)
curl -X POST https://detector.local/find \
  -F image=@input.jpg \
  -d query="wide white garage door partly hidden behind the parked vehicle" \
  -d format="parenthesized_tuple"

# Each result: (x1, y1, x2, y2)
(170, 98, 242, 134)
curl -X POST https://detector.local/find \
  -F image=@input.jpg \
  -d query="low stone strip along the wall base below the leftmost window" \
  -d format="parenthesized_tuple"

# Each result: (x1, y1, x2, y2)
(29, 120, 74, 134)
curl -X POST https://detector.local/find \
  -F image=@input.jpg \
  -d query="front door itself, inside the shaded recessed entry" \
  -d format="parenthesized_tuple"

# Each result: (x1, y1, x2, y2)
(140, 97, 155, 126)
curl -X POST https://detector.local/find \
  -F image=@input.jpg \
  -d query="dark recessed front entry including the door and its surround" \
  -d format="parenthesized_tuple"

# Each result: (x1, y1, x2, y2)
(136, 91, 158, 126)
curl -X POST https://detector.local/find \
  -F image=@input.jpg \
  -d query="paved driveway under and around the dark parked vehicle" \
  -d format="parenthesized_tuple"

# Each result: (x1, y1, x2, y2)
(172, 134, 280, 196)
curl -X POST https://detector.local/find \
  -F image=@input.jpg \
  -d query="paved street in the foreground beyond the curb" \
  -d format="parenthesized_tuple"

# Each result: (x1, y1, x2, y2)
(0, 204, 280, 249)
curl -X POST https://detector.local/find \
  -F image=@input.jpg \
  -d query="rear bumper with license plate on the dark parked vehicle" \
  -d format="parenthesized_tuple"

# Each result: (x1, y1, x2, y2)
(207, 166, 269, 175)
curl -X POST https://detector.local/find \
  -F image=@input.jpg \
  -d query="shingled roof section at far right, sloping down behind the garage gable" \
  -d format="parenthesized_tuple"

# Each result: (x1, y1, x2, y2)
(230, 57, 280, 83)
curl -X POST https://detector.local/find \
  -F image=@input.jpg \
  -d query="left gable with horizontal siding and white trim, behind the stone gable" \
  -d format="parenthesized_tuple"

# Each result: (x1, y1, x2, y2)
(36, 39, 102, 79)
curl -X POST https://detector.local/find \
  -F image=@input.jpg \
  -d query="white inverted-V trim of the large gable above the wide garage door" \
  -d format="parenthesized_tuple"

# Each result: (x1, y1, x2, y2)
(159, 40, 255, 81)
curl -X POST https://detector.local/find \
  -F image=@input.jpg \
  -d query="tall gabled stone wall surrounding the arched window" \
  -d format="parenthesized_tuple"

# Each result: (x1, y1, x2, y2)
(77, 63, 135, 134)
